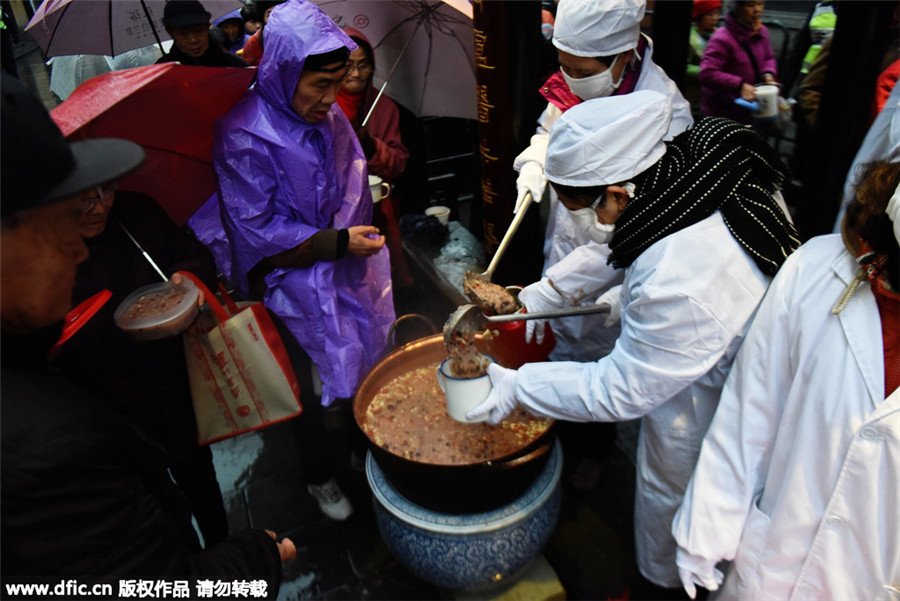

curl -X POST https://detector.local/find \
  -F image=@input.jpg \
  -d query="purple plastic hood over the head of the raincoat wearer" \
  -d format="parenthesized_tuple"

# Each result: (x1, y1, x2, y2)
(255, 0, 356, 118)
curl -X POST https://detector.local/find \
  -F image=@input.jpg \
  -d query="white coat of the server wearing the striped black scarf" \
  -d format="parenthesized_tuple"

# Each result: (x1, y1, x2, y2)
(516, 212, 769, 587)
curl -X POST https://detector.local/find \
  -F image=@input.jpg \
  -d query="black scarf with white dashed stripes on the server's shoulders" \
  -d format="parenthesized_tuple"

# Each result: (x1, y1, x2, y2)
(609, 117, 800, 275)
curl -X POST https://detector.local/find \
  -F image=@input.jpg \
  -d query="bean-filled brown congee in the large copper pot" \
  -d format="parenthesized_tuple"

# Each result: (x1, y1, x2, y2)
(361, 363, 551, 465)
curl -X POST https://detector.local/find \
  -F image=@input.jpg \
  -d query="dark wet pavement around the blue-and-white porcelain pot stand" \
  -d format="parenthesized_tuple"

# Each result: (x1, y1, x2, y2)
(213, 408, 637, 600)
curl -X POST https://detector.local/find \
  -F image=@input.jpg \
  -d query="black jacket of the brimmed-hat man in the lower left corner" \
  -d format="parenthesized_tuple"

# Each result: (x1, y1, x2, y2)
(0, 328, 281, 598)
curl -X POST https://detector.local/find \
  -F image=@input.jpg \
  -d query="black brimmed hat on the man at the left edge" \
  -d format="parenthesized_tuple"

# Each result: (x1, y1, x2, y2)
(0, 73, 144, 217)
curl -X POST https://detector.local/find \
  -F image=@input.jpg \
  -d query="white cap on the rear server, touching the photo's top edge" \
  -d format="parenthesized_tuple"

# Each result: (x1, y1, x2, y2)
(553, 0, 647, 58)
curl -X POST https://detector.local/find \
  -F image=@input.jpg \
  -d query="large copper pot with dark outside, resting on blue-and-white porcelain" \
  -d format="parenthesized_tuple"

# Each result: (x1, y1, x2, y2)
(353, 334, 555, 513)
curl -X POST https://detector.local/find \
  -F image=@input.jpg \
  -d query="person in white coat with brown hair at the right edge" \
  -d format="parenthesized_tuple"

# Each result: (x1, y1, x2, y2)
(672, 163, 900, 599)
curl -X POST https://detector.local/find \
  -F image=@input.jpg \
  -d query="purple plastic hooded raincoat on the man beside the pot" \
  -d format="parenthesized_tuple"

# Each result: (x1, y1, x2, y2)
(189, 0, 394, 405)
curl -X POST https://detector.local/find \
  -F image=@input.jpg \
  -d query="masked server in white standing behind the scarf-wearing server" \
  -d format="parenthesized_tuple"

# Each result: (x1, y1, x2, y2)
(513, 0, 693, 361)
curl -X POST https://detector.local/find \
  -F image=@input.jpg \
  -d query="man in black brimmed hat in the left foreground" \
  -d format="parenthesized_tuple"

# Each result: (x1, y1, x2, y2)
(0, 73, 296, 598)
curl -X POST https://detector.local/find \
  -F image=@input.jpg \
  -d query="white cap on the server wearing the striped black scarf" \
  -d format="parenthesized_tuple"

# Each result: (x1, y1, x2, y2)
(544, 90, 672, 187)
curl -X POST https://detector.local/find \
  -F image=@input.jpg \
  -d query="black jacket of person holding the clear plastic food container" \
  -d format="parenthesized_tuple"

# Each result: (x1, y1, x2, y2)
(54, 191, 216, 462)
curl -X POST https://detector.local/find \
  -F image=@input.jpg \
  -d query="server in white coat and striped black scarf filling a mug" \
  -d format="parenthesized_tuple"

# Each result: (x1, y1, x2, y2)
(469, 91, 799, 588)
